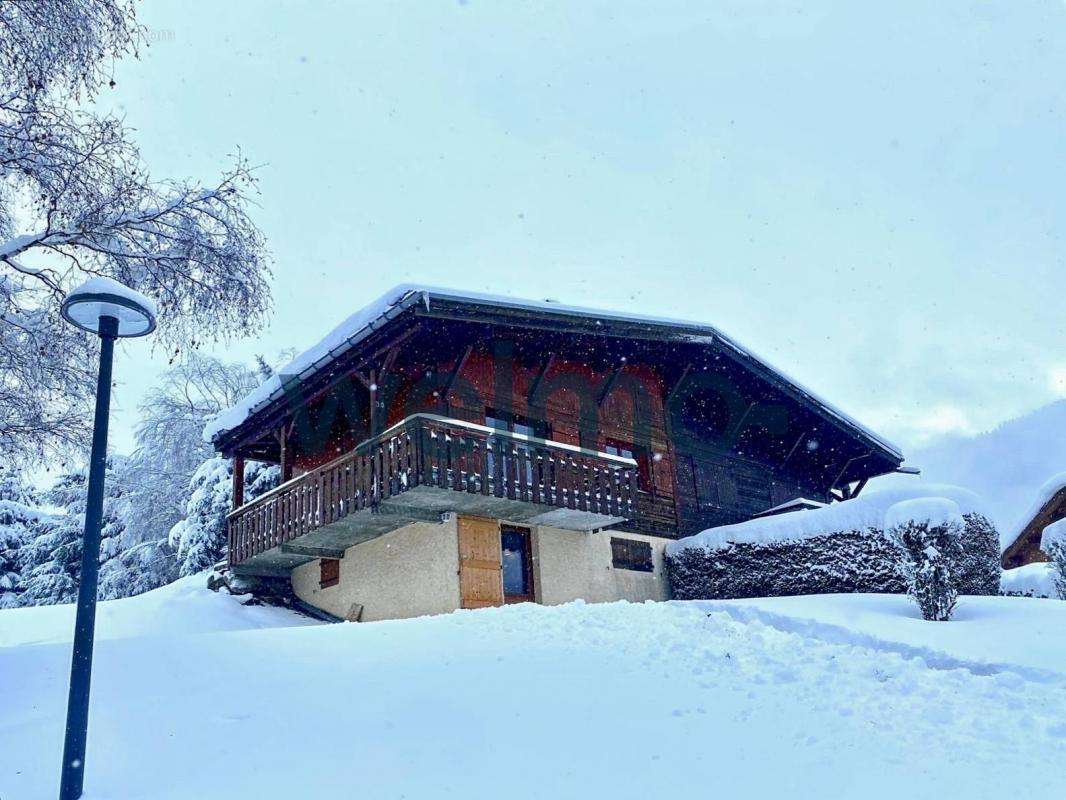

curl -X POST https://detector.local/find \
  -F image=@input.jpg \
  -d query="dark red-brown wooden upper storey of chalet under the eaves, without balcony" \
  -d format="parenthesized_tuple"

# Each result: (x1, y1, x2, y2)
(215, 294, 902, 567)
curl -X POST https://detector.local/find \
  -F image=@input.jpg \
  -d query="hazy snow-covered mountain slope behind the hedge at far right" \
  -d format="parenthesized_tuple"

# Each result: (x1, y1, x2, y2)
(871, 400, 1066, 546)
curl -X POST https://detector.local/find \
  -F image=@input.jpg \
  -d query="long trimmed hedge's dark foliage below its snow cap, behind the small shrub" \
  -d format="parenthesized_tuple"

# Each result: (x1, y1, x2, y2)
(666, 512, 1000, 599)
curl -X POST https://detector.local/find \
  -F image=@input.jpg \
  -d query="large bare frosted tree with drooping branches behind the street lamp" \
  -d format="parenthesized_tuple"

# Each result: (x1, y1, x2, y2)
(0, 0, 270, 457)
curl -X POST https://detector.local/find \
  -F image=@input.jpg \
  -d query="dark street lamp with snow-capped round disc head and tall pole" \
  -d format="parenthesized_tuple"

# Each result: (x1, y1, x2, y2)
(60, 277, 156, 800)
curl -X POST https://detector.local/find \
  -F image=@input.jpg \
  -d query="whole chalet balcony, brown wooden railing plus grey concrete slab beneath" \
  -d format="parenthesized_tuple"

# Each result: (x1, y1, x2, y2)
(228, 414, 636, 575)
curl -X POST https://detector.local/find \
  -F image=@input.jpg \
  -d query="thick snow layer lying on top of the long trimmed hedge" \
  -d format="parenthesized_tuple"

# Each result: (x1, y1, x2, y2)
(666, 483, 985, 555)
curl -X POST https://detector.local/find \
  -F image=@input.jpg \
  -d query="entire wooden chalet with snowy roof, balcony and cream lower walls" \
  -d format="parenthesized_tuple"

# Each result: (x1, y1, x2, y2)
(208, 287, 903, 619)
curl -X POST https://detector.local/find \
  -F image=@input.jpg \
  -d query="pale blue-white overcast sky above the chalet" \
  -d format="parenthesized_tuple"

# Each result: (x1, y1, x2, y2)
(95, 0, 1066, 460)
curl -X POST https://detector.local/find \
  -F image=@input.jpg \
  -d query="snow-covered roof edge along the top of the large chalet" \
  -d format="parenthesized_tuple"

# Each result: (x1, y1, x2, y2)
(204, 284, 903, 459)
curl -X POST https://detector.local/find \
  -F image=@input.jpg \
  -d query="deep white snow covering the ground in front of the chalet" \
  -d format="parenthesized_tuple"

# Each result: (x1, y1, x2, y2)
(0, 581, 1066, 800)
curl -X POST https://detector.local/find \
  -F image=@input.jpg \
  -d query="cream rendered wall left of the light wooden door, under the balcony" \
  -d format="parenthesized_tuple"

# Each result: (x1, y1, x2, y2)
(292, 516, 459, 622)
